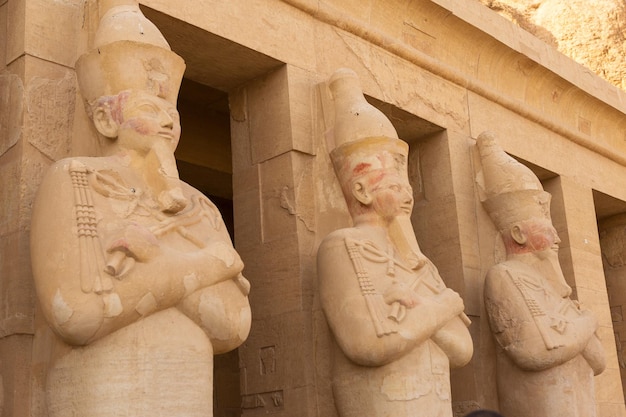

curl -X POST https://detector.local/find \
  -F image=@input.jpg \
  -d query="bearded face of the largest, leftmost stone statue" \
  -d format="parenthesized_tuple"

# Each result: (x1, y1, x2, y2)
(117, 90, 180, 152)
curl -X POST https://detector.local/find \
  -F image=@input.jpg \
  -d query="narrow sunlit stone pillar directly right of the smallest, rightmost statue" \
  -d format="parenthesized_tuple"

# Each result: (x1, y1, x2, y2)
(544, 177, 624, 417)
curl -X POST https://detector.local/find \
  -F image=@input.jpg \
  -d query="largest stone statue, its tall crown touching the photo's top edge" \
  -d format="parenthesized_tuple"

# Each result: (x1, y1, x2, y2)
(31, 0, 251, 417)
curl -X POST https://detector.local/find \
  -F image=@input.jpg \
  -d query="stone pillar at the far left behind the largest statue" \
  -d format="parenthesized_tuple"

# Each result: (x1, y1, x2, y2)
(0, 0, 84, 417)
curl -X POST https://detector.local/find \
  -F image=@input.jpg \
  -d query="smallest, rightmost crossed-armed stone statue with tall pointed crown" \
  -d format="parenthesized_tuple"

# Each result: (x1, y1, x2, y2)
(477, 132, 605, 417)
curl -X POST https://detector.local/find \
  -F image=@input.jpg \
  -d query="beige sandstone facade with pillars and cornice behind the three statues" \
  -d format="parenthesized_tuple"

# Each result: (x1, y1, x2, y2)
(0, 0, 626, 417)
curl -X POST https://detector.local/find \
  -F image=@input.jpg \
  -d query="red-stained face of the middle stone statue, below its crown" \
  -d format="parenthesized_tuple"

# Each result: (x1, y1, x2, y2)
(370, 173, 413, 221)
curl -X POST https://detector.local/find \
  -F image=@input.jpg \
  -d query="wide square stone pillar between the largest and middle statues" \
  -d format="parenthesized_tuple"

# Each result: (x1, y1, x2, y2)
(230, 65, 317, 417)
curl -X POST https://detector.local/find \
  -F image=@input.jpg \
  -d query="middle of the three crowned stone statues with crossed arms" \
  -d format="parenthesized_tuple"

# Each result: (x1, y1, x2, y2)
(317, 70, 473, 417)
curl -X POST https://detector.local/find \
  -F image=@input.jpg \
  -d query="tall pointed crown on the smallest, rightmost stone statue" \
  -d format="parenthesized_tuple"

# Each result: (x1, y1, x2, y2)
(476, 132, 551, 230)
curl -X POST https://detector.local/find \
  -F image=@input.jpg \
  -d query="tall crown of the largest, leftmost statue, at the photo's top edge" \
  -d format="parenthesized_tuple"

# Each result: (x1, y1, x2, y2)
(76, 0, 185, 103)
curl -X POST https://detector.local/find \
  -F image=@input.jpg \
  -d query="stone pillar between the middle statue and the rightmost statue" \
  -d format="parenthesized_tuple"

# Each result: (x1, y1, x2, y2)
(409, 130, 486, 416)
